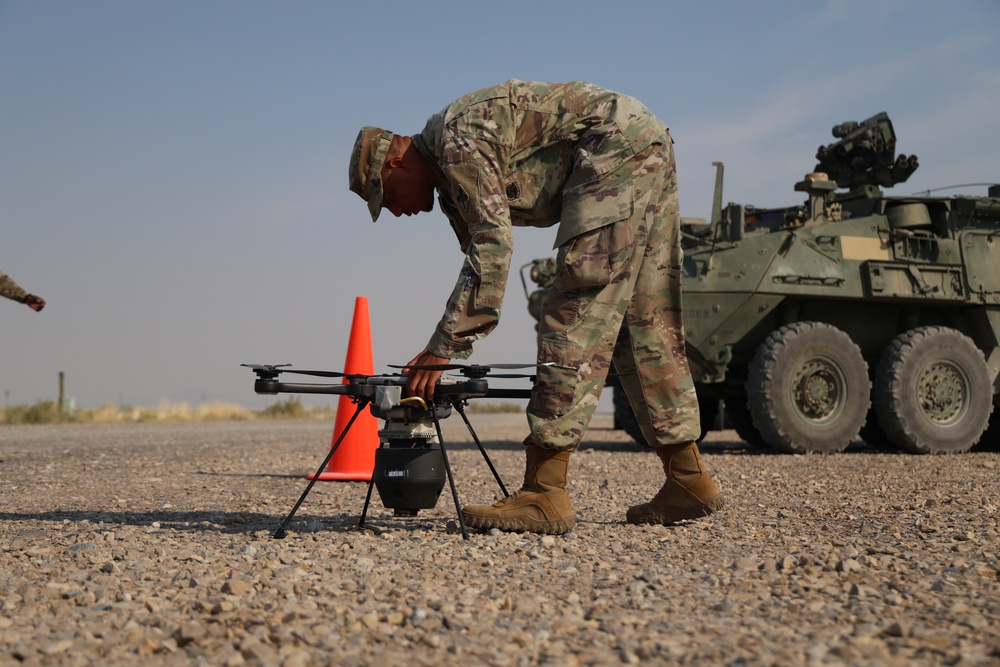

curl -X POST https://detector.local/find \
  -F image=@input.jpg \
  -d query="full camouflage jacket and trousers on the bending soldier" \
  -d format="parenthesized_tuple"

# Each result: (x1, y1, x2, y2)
(413, 80, 699, 451)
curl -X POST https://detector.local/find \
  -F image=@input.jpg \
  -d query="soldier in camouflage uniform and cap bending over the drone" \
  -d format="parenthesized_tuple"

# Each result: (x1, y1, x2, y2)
(350, 80, 722, 534)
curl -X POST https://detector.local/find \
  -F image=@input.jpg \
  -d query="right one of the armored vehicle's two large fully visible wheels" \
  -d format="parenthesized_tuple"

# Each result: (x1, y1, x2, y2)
(875, 326, 993, 454)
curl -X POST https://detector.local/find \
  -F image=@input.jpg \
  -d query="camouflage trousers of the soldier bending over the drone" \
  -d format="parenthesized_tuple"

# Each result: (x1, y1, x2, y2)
(525, 144, 701, 451)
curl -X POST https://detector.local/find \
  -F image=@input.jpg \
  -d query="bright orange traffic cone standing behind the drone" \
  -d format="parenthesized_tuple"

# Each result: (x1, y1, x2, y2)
(309, 296, 378, 482)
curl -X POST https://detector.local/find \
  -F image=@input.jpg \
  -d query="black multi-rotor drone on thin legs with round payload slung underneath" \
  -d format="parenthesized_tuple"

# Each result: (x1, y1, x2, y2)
(242, 363, 552, 540)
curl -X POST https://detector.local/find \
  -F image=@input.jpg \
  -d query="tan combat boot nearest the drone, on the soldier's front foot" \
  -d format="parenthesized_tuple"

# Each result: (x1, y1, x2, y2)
(462, 445, 576, 535)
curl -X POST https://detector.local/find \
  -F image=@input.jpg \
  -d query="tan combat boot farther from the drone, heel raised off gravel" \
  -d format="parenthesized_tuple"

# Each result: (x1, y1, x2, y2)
(625, 442, 723, 525)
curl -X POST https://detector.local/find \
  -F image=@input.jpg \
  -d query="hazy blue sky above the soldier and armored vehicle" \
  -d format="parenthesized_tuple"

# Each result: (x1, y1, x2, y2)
(0, 0, 1000, 408)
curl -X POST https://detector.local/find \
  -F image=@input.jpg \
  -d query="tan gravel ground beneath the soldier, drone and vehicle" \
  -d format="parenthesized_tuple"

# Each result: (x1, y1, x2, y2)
(0, 414, 1000, 667)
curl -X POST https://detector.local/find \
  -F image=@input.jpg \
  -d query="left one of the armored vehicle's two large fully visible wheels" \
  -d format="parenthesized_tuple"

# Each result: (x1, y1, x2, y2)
(747, 322, 871, 454)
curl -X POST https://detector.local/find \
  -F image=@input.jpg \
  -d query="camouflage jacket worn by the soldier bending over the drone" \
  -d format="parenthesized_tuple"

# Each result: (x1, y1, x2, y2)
(413, 80, 669, 358)
